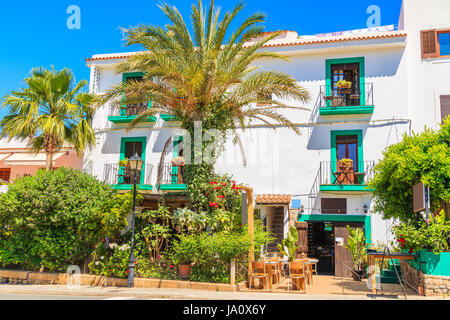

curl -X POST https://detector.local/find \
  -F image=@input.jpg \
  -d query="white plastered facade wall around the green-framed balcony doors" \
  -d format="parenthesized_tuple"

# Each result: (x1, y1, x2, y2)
(86, 33, 409, 244)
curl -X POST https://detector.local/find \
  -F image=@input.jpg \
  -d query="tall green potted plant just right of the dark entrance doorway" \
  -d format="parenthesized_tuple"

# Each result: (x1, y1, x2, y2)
(344, 225, 367, 281)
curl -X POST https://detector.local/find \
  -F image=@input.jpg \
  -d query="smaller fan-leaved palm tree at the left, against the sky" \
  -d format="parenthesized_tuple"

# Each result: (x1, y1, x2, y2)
(0, 67, 95, 170)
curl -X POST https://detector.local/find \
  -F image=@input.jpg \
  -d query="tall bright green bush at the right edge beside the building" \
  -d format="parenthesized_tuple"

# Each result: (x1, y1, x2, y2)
(369, 118, 450, 223)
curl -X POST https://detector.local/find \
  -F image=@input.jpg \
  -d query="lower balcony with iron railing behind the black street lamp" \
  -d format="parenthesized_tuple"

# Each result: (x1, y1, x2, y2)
(103, 163, 153, 186)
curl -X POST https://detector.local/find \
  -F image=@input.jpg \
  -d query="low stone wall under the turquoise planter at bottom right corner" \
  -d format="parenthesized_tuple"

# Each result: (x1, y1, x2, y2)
(400, 261, 450, 296)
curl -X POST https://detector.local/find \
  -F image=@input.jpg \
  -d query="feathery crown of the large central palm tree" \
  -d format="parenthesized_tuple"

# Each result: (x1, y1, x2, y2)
(99, 0, 310, 180)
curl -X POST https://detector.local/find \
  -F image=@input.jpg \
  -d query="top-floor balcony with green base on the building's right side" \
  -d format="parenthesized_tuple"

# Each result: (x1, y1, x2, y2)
(318, 83, 374, 116)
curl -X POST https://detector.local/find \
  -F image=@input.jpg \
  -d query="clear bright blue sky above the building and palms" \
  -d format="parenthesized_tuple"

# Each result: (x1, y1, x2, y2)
(0, 0, 401, 118)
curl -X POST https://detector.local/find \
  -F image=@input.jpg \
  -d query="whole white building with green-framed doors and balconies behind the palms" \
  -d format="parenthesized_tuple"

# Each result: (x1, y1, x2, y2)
(85, 0, 450, 275)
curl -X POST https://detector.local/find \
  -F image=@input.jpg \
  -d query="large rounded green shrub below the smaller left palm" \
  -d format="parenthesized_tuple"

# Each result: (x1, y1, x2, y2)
(0, 167, 131, 271)
